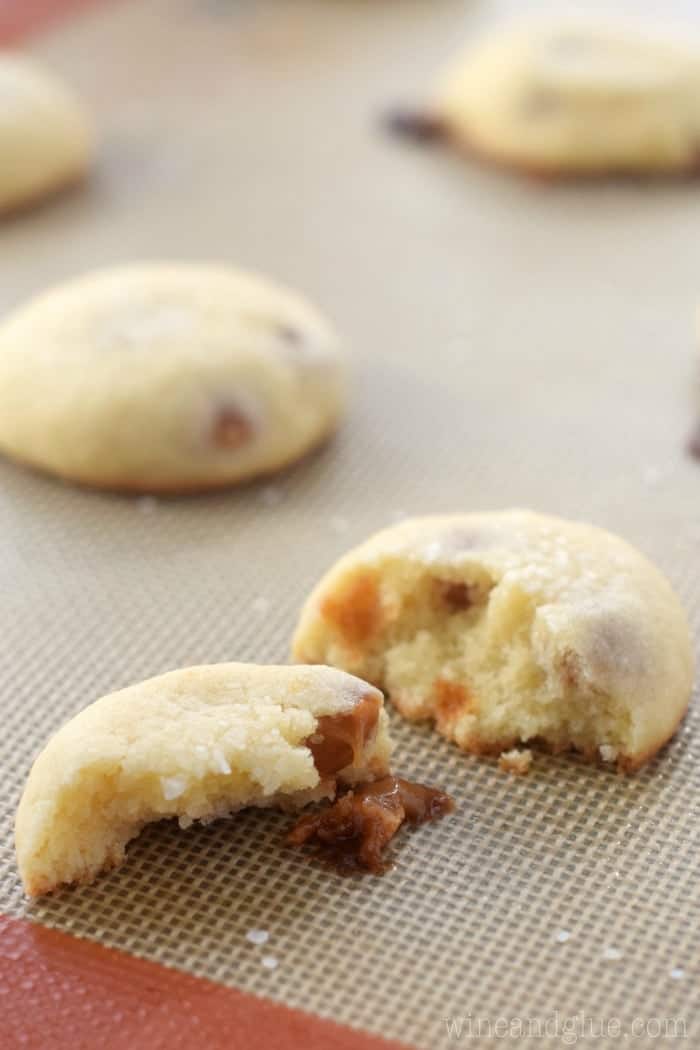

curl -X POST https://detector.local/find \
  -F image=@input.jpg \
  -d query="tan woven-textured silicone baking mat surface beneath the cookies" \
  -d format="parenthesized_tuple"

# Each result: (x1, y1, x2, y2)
(0, 0, 700, 1050)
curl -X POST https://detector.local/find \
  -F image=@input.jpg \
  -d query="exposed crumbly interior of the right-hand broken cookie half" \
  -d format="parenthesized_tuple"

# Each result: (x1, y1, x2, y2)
(321, 558, 634, 761)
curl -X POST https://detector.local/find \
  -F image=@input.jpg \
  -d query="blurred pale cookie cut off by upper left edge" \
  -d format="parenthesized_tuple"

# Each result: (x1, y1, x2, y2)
(0, 51, 92, 213)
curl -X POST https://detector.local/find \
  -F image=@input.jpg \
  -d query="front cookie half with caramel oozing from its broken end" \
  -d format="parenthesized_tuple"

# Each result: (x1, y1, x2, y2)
(15, 664, 390, 897)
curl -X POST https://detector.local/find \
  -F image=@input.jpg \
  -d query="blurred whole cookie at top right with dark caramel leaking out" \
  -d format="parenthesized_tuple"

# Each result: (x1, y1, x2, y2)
(434, 18, 700, 174)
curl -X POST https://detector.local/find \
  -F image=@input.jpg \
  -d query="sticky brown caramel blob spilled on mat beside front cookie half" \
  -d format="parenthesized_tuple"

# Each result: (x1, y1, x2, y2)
(287, 776, 454, 875)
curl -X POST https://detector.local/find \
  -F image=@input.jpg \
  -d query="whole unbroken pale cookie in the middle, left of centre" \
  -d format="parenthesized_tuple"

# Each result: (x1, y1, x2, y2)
(0, 264, 345, 492)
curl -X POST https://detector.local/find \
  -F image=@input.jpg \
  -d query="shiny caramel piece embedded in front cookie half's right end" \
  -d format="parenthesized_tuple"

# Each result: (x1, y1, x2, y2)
(306, 693, 381, 778)
